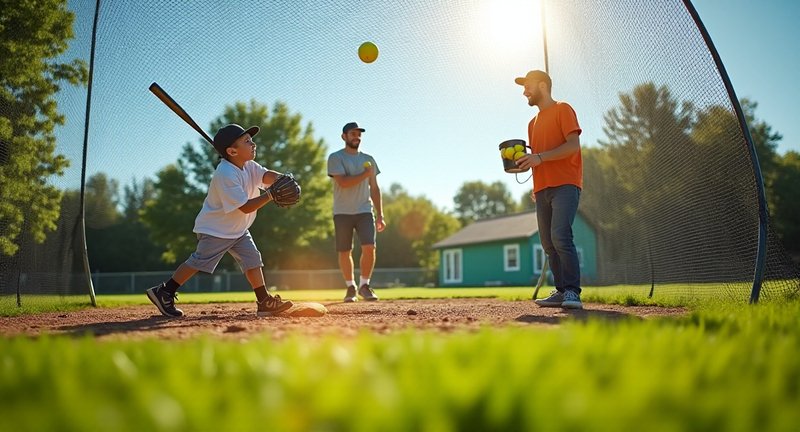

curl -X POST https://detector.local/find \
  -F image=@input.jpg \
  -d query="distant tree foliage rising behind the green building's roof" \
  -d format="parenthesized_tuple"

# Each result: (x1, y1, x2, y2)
(453, 180, 517, 225)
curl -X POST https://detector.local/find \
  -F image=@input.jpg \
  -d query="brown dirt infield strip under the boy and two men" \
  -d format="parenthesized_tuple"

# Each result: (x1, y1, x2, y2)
(0, 298, 686, 339)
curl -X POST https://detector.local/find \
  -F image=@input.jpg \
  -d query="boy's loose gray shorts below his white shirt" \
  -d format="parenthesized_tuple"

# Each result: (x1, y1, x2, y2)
(186, 231, 264, 273)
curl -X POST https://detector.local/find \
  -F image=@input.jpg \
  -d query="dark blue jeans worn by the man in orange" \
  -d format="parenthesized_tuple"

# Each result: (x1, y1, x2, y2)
(536, 185, 581, 294)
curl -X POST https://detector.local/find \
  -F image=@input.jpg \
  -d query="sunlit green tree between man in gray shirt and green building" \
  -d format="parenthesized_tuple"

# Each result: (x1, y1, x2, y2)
(376, 183, 461, 269)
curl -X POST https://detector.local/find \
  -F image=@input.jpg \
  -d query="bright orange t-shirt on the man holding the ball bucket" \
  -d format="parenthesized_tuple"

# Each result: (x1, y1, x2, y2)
(528, 102, 583, 193)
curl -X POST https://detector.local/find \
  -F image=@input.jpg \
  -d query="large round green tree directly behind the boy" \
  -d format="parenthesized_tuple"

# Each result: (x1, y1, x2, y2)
(142, 101, 333, 268)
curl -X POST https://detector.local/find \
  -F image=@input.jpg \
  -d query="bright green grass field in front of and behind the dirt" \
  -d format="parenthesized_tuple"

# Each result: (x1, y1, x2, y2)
(0, 288, 800, 431)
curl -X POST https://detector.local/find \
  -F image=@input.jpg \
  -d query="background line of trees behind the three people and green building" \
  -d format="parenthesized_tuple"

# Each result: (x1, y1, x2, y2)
(76, 83, 800, 271)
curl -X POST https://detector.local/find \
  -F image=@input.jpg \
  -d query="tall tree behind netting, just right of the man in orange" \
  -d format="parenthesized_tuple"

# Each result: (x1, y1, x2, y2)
(581, 82, 694, 266)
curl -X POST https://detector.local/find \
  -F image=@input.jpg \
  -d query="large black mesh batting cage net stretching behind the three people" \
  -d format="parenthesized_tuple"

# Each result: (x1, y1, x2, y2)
(0, 0, 799, 304)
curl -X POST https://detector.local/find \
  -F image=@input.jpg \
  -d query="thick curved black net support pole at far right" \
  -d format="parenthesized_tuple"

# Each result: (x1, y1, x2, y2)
(683, 0, 769, 304)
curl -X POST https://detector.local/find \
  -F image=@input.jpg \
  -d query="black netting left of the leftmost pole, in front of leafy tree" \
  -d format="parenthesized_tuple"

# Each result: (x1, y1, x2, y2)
(0, 2, 94, 304)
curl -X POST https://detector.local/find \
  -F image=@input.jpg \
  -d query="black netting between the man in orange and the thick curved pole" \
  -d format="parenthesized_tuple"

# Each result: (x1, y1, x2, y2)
(547, 0, 798, 300)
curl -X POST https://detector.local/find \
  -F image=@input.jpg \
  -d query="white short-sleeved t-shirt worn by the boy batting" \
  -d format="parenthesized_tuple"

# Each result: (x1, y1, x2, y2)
(193, 159, 267, 239)
